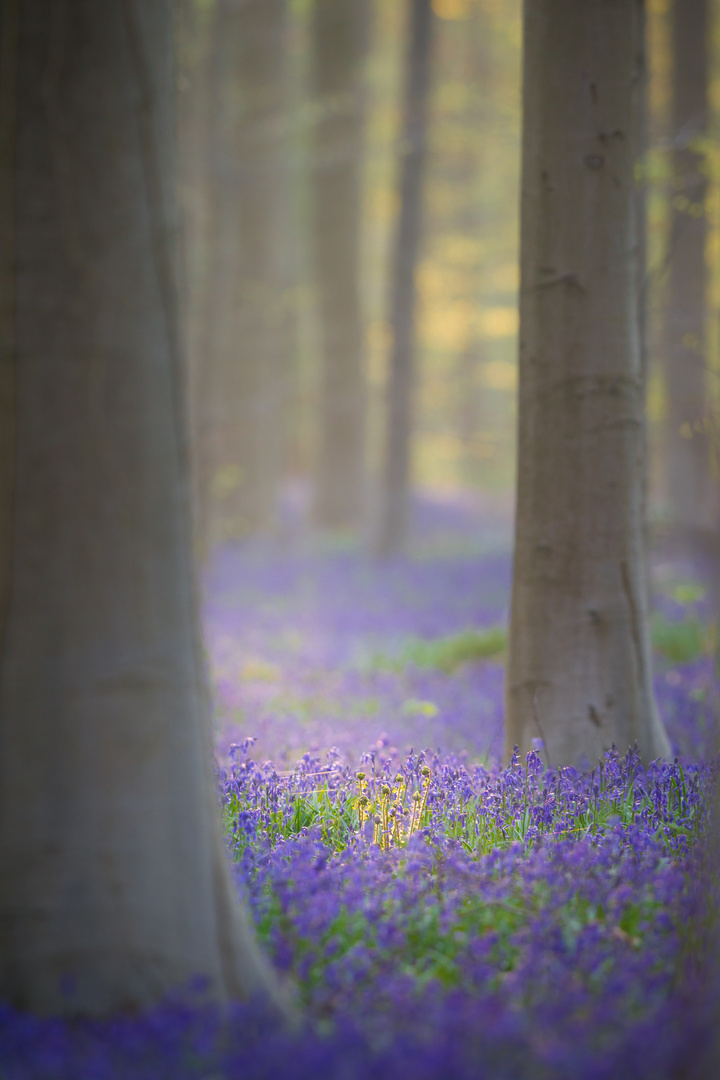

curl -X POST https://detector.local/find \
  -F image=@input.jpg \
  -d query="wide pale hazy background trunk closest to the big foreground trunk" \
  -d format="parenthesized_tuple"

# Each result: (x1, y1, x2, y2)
(195, 0, 290, 551)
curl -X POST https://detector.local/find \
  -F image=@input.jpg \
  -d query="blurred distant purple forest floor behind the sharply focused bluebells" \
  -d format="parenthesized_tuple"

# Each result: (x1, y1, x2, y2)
(204, 500, 717, 769)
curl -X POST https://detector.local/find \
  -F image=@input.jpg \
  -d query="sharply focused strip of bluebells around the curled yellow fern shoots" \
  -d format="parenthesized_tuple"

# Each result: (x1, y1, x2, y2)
(219, 739, 708, 856)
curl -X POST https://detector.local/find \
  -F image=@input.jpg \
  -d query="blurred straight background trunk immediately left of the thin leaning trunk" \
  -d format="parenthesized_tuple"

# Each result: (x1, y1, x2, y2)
(311, 0, 368, 528)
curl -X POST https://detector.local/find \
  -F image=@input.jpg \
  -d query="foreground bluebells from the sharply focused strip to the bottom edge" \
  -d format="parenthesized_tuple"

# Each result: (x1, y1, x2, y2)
(0, 741, 712, 1080)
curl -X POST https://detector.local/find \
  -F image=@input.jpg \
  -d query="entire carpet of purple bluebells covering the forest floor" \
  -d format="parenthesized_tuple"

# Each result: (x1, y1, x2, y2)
(0, 501, 717, 1080)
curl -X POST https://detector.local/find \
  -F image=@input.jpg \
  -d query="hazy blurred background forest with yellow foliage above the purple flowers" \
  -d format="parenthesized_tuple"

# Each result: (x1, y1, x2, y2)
(178, 0, 720, 557)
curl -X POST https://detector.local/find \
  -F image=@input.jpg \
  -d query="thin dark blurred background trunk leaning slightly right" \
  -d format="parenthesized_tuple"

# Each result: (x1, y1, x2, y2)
(378, 0, 433, 555)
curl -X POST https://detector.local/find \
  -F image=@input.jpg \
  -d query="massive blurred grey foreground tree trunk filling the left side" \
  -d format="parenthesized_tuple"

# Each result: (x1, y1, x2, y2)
(0, 0, 274, 1013)
